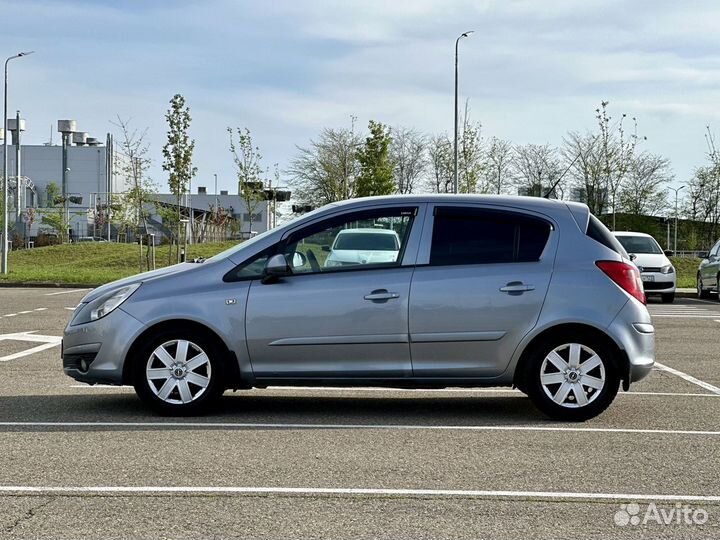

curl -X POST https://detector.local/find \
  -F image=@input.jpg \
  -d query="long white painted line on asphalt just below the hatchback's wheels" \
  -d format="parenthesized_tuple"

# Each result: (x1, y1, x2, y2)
(0, 421, 720, 437)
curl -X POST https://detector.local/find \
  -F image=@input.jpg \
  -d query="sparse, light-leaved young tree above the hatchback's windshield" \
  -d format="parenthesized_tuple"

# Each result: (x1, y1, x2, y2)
(227, 127, 265, 237)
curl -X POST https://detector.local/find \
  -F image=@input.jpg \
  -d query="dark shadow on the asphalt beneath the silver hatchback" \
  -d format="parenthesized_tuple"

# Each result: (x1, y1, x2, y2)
(0, 391, 551, 431)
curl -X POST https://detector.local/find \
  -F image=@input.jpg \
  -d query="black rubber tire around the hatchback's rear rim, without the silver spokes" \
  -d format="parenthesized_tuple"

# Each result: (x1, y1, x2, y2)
(525, 334, 620, 422)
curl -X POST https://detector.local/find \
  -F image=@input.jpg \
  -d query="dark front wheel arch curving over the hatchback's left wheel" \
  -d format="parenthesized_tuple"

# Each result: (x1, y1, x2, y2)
(122, 319, 247, 388)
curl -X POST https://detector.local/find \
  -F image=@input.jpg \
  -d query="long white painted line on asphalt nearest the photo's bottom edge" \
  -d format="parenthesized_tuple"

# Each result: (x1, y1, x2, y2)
(0, 486, 720, 502)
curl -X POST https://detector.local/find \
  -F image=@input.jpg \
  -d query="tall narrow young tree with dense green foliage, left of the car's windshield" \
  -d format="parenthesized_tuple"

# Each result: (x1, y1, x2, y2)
(163, 94, 197, 262)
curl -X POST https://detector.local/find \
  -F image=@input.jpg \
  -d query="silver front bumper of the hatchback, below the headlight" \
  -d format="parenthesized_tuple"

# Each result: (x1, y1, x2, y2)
(62, 308, 143, 385)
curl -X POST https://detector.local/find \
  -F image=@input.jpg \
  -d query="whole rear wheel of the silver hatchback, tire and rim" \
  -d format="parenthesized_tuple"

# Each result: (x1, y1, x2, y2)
(526, 335, 620, 422)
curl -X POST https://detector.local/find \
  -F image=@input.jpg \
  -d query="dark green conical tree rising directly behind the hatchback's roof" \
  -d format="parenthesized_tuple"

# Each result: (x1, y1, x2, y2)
(355, 120, 395, 197)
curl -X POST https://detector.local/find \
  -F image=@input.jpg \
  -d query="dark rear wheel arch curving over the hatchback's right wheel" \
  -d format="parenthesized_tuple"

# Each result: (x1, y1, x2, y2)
(513, 323, 630, 390)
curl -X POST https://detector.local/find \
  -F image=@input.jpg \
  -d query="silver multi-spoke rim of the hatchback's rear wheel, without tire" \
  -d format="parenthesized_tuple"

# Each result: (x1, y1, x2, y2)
(540, 343, 606, 408)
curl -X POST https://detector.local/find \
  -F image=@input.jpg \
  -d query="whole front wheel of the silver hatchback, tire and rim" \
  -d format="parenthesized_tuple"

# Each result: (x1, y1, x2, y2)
(133, 331, 224, 416)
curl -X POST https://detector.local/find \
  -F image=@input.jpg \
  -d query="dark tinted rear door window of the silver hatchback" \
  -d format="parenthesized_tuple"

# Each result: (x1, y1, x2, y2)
(430, 207, 551, 265)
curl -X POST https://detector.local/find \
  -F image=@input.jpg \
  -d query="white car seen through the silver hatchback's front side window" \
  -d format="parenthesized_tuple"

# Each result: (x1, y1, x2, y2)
(325, 229, 400, 267)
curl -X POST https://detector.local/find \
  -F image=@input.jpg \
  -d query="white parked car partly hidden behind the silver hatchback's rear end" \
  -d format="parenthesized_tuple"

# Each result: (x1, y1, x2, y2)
(614, 232, 677, 303)
